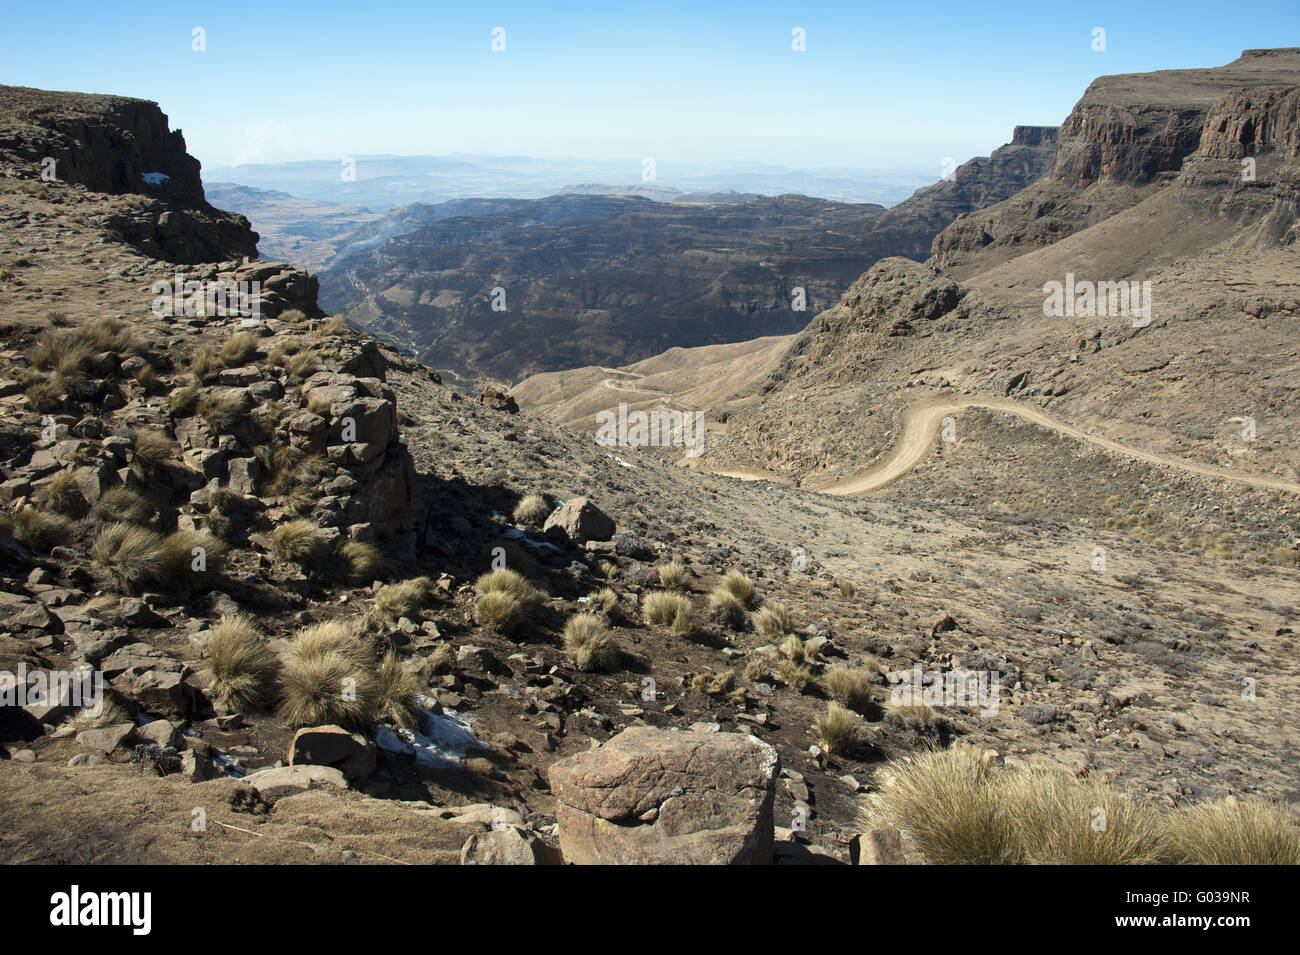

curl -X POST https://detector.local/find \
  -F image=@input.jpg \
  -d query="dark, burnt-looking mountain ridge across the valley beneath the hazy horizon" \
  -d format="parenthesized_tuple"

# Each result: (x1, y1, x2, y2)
(322, 127, 1056, 379)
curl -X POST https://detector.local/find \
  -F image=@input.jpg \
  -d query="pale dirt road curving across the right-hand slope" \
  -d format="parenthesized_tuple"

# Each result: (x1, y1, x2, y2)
(716, 395, 1300, 498)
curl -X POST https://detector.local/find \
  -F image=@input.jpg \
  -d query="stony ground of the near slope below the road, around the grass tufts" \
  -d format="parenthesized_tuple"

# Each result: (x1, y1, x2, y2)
(0, 72, 1300, 863)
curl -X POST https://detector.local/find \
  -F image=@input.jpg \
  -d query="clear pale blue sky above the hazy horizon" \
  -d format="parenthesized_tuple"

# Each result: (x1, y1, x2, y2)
(0, 0, 1300, 179)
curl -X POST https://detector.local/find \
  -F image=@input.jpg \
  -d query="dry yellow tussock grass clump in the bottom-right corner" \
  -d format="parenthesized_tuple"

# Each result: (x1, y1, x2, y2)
(1160, 796, 1300, 865)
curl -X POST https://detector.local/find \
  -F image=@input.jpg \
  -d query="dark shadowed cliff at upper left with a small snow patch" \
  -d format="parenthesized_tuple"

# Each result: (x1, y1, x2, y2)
(0, 86, 257, 264)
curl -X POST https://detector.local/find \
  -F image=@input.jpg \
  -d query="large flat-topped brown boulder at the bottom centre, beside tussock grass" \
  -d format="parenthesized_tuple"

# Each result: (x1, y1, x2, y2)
(549, 726, 780, 865)
